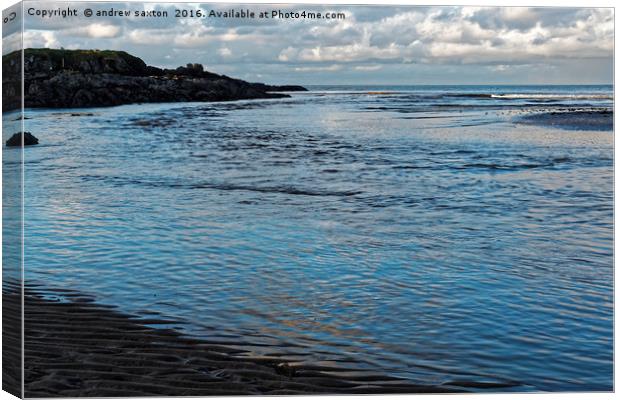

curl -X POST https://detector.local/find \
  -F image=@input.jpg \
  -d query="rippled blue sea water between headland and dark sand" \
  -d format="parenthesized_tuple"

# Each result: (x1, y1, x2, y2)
(5, 86, 613, 391)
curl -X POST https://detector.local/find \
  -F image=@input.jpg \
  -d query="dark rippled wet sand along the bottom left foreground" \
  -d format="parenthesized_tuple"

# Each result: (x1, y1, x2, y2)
(4, 289, 463, 397)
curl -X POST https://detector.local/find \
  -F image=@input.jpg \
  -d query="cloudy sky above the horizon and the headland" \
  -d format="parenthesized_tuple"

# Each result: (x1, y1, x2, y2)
(5, 1, 614, 84)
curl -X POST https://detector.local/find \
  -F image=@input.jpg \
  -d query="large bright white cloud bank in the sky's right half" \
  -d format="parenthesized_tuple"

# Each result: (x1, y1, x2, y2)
(278, 7, 614, 64)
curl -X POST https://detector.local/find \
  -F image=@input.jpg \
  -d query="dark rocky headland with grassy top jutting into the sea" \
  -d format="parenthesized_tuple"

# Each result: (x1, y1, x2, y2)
(2, 49, 306, 111)
